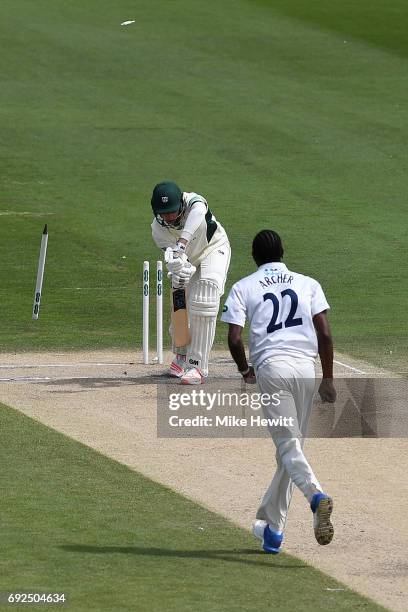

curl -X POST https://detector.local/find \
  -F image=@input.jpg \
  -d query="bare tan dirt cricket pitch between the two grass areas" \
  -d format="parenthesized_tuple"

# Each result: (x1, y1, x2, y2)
(0, 351, 408, 611)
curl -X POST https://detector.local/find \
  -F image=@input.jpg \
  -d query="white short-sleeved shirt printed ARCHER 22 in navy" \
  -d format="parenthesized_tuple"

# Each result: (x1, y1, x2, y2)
(221, 262, 330, 367)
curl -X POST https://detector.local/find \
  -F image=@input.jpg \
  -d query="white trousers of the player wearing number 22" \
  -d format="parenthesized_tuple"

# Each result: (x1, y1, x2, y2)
(256, 357, 322, 531)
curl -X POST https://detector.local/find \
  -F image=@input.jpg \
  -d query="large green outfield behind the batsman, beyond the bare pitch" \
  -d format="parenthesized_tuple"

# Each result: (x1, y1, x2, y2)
(0, 0, 408, 369)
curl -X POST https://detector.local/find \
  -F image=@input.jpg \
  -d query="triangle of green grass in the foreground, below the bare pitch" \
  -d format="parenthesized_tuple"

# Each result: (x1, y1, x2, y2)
(0, 405, 384, 612)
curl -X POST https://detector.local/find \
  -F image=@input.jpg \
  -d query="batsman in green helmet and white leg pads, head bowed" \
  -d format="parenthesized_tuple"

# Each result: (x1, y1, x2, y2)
(151, 181, 231, 385)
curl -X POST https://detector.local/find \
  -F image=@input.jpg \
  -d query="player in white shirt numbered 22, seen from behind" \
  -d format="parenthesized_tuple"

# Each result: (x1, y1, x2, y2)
(221, 230, 336, 553)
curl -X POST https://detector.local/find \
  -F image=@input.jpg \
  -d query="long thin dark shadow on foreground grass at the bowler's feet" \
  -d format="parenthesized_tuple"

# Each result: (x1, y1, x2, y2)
(59, 544, 309, 569)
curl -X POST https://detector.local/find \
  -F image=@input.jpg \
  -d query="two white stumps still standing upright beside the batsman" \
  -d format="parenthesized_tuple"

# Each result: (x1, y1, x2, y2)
(143, 261, 163, 364)
